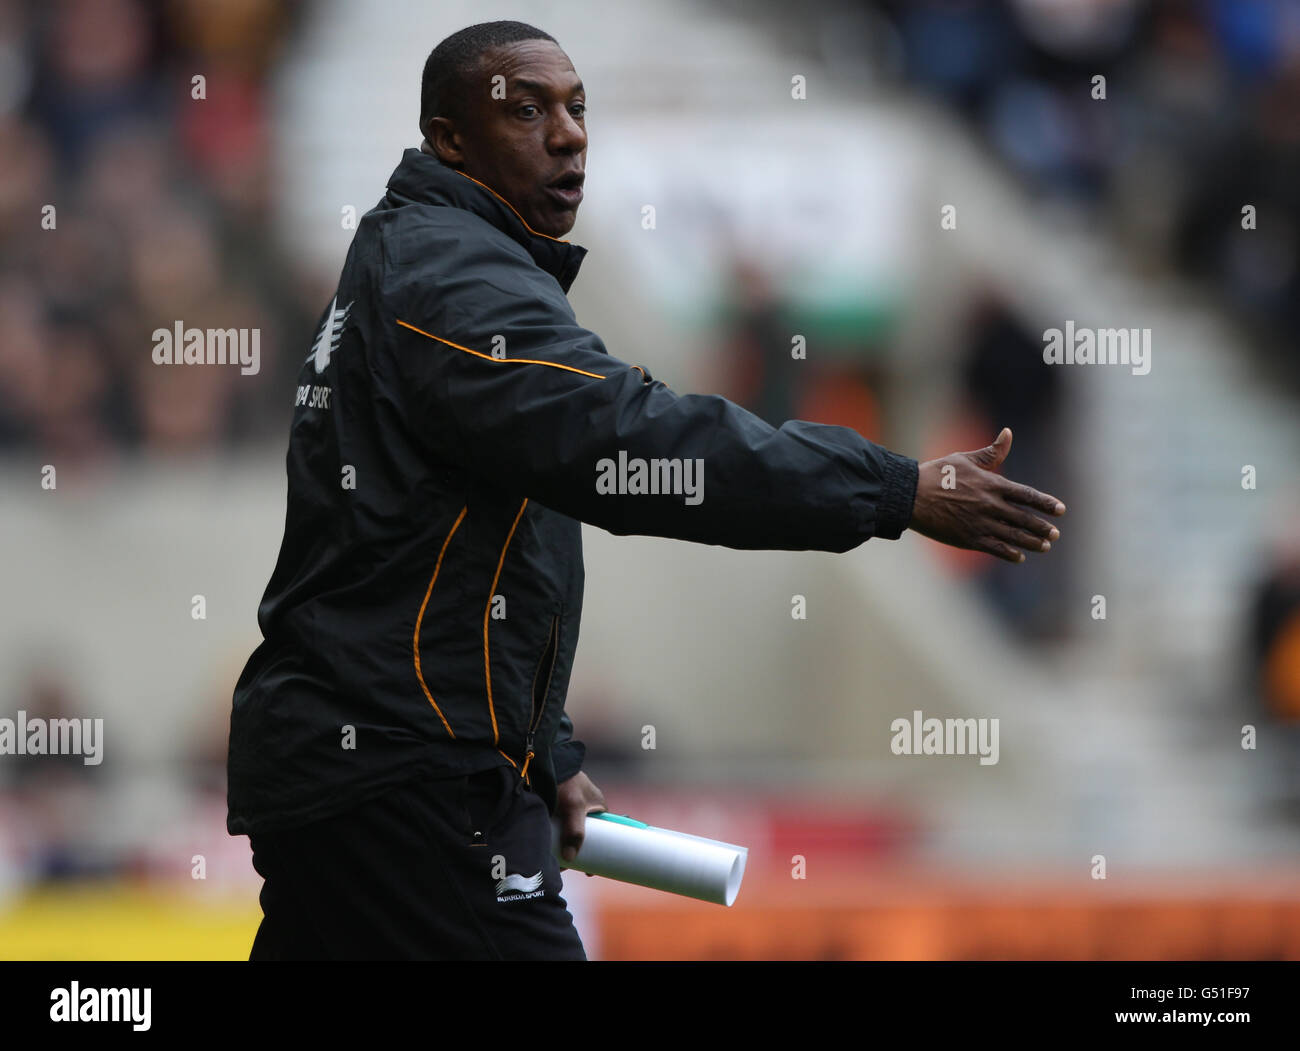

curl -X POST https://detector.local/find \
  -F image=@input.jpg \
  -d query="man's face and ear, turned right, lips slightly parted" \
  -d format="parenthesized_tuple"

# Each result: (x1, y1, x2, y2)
(429, 40, 586, 237)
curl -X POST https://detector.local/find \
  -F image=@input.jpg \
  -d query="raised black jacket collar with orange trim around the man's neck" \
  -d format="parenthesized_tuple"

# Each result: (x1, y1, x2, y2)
(389, 150, 586, 294)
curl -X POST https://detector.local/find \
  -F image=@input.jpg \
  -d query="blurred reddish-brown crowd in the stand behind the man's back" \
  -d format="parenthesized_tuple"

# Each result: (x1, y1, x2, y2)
(0, 0, 321, 467)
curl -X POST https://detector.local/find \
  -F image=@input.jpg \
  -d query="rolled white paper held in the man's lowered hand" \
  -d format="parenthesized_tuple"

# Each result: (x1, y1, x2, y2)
(551, 813, 749, 907)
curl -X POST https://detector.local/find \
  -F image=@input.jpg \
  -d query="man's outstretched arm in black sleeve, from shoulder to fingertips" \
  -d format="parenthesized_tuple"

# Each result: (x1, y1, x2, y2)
(387, 230, 1058, 561)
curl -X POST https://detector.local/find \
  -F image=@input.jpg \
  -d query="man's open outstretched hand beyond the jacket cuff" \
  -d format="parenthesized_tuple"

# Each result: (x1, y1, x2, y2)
(907, 427, 1065, 562)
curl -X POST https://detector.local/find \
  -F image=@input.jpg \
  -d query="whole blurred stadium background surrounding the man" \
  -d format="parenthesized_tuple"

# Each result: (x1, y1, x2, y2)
(0, 0, 1300, 959)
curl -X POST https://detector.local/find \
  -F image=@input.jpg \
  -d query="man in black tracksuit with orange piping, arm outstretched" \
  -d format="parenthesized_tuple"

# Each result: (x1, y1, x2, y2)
(228, 22, 1065, 959)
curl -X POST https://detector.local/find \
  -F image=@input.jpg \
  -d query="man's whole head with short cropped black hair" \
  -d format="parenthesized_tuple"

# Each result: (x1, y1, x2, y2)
(420, 22, 586, 237)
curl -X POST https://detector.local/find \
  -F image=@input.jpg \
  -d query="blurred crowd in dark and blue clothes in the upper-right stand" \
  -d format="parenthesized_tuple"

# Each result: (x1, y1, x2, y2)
(878, 0, 1300, 386)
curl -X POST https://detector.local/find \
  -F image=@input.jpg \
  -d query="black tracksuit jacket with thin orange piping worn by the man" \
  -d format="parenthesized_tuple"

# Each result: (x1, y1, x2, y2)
(228, 150, 917, 835)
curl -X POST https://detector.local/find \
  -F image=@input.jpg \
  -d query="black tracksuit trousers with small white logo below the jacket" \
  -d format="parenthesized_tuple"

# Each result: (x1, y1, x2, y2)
(248, 766, 586, 960)
